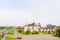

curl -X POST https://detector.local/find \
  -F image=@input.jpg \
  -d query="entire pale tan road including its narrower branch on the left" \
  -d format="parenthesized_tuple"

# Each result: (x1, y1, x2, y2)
(0, 29, 60, 40)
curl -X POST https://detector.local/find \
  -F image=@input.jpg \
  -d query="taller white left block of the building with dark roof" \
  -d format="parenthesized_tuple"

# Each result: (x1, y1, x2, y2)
(24, 23, 41, 32)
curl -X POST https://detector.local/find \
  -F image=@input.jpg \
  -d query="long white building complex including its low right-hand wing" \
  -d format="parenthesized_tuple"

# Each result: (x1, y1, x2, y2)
(24, 22, 56, 32)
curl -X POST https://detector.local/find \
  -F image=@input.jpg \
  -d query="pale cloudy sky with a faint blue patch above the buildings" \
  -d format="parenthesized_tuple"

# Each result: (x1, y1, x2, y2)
(0, 0, 60, 26)
